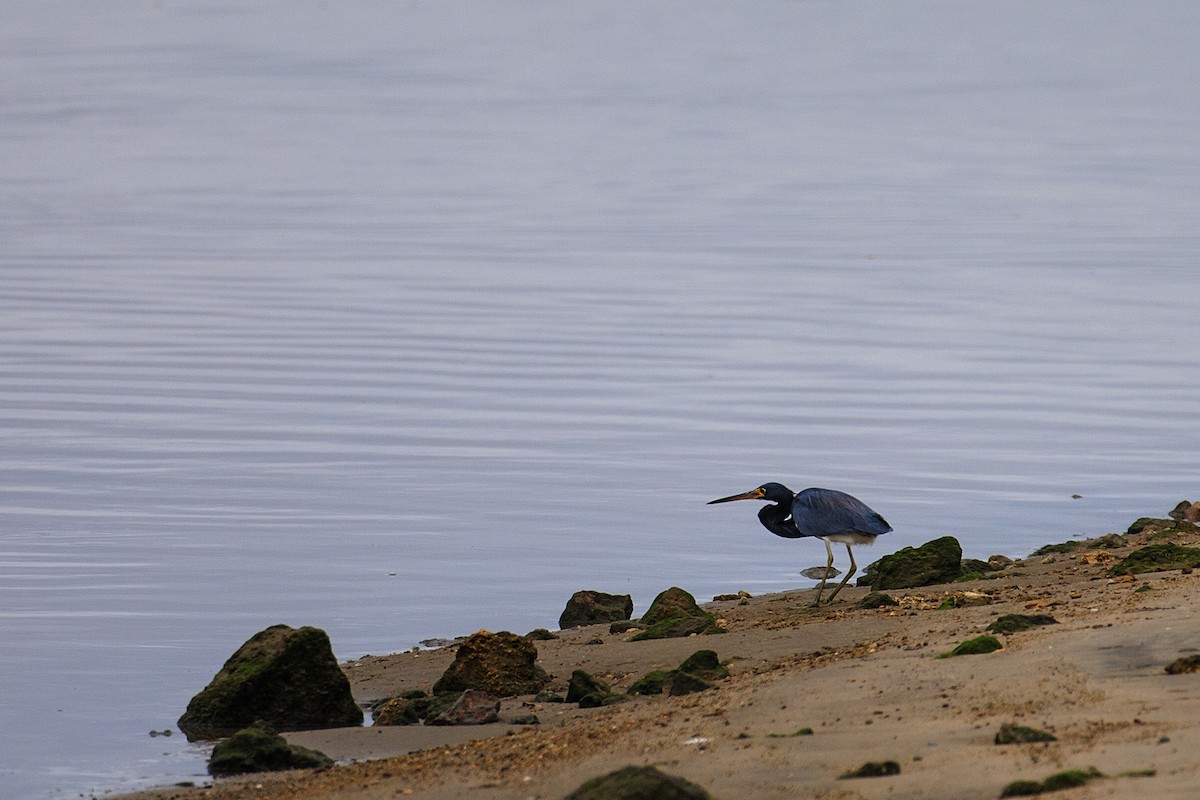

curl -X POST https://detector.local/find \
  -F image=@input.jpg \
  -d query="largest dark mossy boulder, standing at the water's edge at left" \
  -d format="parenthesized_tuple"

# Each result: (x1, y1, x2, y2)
(179, 625, 362, 741)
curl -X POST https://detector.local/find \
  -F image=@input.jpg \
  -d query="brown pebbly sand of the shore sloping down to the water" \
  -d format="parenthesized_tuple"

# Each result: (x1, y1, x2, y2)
(121, 522, 1200, 800)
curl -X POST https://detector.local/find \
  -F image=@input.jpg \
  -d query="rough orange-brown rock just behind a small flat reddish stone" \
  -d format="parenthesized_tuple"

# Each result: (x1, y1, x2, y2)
(433, 631, 550, 697)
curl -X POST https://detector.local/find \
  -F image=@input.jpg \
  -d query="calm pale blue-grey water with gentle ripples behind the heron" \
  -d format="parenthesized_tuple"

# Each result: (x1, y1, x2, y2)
(0, 0, 1200, 799)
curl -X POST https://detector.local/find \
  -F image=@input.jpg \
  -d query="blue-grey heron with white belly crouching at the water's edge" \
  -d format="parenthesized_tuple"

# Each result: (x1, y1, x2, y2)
(708, 483, 892, 606)
